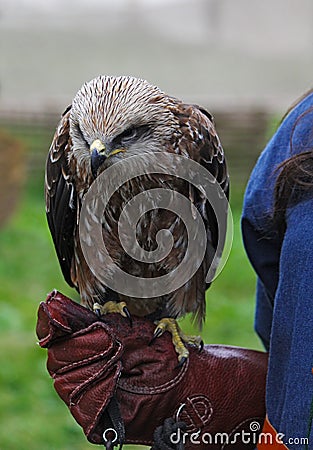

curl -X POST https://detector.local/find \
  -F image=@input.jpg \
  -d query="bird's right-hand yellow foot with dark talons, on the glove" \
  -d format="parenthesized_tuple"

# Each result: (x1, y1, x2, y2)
(154, 318, 203, 366)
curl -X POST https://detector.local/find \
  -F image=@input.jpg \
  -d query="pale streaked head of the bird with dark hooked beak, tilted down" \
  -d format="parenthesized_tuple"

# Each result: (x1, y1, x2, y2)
(70, 76, 179, 178)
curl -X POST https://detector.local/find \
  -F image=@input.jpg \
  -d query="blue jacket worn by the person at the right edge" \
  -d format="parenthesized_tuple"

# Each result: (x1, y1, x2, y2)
(242, 94, 313, 450)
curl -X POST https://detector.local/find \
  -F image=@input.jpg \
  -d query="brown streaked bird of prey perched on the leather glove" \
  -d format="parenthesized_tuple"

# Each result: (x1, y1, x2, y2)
(45, 76, 229, 362)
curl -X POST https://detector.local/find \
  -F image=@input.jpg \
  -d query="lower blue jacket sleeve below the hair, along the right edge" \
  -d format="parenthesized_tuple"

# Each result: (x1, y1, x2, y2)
(267, 198, 313, 450)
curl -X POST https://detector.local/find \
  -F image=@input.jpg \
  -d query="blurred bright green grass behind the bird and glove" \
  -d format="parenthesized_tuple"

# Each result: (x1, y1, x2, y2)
(0, 139, 260, 450)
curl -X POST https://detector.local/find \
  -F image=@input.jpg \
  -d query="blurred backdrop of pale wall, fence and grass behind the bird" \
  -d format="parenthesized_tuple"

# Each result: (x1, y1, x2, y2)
(0, 0, 313, 450)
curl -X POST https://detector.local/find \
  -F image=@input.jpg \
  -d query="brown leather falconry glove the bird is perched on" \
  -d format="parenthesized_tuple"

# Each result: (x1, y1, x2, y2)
(37, 291, 267, 450)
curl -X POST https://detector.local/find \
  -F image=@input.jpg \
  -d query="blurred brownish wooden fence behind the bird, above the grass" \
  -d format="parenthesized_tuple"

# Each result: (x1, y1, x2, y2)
(0, 109, 273, 190)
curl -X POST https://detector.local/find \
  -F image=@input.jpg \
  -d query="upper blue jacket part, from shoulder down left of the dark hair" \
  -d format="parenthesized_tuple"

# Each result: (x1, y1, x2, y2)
(242, 94, 313, 350)
